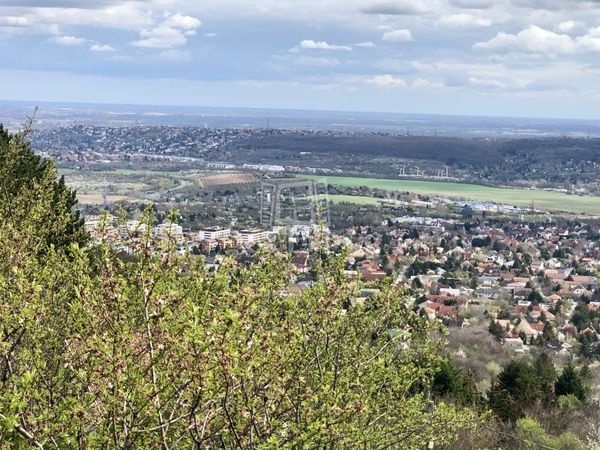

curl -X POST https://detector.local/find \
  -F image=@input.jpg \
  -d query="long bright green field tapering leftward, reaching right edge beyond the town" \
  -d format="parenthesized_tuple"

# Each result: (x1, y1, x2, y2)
(302, 175, 600, 215)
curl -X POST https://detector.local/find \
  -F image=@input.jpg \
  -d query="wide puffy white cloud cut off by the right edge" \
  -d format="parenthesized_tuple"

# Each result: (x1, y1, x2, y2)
(473, 25, 600, 57)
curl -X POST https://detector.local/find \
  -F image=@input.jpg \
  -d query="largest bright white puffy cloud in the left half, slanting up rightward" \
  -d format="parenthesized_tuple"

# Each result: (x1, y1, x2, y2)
(130, 13, 202, 49)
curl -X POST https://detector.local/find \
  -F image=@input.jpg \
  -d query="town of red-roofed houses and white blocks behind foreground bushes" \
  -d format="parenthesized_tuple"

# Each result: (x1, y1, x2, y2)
(85, 206, 600, 368)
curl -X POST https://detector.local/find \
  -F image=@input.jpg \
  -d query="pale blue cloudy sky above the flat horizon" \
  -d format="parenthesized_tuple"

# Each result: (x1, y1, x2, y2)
(0, 0, 600, 119)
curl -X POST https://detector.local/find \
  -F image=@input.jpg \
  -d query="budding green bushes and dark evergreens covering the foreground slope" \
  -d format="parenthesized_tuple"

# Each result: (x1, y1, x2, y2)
(0, 125, 598, 449)
